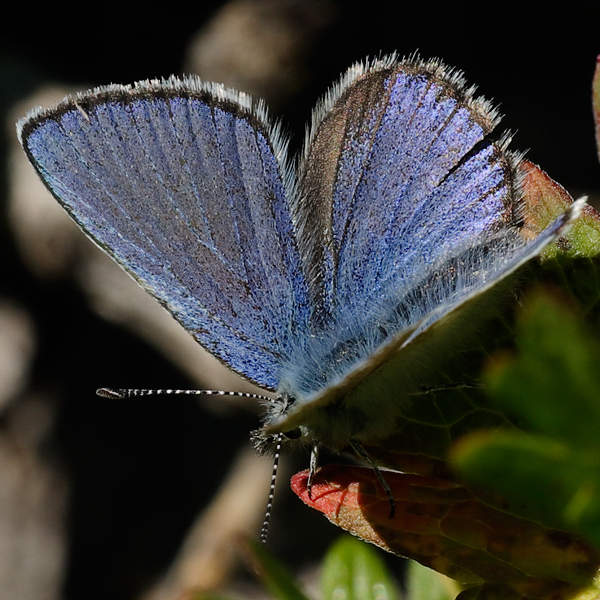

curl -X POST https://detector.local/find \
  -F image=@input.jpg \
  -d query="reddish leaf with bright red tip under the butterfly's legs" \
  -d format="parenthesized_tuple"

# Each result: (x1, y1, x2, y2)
(292, 465, 600, 600)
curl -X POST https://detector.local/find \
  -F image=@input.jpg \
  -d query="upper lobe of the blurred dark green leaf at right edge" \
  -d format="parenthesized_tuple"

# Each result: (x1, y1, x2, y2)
(486, 293, 600, 448)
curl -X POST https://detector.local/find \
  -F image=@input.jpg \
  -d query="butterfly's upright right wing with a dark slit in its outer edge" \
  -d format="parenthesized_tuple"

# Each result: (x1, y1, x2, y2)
(301, 61, 520, 325)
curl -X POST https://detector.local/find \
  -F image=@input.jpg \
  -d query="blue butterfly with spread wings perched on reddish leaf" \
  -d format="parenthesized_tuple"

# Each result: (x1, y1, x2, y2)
(18, 56, 585, 502)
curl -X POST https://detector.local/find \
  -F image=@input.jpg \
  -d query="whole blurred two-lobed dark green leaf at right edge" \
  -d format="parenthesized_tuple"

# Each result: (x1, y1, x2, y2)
(454, 292, 600, 548)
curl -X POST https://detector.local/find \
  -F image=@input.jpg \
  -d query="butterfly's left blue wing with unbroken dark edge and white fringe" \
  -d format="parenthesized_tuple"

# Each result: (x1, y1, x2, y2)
(18, 78, 307, 389)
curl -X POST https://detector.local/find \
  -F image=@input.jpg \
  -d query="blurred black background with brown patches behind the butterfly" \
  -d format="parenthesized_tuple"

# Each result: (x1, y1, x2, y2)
(0, 0, 600, 600)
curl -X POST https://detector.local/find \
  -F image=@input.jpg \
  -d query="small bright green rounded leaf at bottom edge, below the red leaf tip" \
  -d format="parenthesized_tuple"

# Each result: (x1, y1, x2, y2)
(321, 536, 400, 600)
